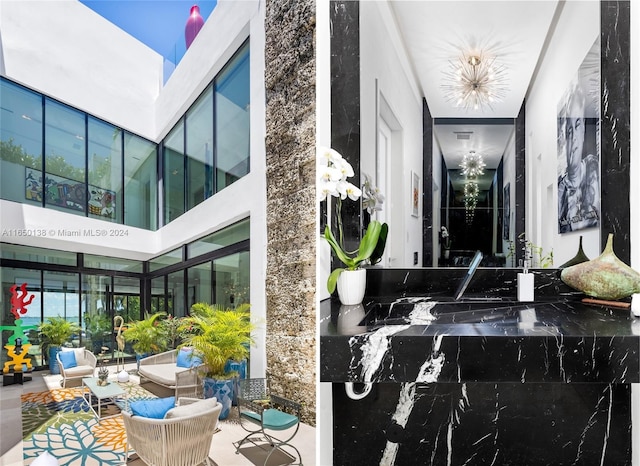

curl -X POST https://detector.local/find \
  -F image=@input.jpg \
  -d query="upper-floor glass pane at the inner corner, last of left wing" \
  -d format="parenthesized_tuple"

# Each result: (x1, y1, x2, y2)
(124, 133, 158, 230)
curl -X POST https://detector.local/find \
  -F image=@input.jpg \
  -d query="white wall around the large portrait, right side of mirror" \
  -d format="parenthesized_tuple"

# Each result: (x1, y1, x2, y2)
(525, 1, 601, 266)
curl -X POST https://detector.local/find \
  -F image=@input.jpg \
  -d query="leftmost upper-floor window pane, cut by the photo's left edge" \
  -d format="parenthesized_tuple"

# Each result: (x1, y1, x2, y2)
(0, 80, 44, 205)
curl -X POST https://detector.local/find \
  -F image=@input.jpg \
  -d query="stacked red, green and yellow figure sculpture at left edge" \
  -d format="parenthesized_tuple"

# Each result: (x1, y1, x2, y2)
(0, 283, 38, 375)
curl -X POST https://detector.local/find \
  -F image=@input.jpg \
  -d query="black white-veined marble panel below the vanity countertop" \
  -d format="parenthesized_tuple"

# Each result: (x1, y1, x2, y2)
(334, 383, 631, 466)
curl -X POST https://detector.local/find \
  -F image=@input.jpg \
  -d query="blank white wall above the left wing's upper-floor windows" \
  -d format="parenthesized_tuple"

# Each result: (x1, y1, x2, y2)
(0, 0, 162, 139)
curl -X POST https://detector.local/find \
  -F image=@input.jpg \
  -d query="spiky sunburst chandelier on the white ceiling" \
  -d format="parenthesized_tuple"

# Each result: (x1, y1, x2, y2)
(442, 52, 508, 110)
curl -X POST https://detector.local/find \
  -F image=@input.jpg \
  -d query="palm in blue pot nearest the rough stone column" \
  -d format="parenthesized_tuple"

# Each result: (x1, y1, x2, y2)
(180, 303, 255, 419)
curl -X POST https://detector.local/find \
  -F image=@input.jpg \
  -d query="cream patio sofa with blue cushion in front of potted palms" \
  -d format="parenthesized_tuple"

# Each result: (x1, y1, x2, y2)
(138, 348, 202, 400)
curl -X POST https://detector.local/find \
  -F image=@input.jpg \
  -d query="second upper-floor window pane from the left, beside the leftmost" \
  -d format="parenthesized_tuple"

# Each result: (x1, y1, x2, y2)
(44, 99, 87, 215)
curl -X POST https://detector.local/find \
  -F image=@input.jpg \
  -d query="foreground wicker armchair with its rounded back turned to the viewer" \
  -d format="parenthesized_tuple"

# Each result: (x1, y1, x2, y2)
(122, 397, 222, 466)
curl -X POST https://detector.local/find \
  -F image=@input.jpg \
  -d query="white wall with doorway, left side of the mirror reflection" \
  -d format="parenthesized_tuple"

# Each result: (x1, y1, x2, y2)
(360, 1, 422, 267)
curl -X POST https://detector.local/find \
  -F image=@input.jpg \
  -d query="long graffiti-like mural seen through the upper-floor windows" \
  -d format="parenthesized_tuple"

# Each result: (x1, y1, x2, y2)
(25, 167, 116, 218)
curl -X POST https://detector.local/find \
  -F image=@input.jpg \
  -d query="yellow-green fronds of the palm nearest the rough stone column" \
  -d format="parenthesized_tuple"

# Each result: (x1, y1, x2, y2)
(180, 303, 255, 379)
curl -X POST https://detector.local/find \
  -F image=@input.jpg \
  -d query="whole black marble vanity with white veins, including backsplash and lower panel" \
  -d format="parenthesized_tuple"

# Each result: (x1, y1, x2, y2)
(328, 269, 640, 466)
